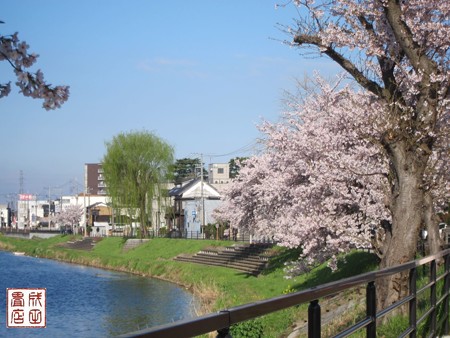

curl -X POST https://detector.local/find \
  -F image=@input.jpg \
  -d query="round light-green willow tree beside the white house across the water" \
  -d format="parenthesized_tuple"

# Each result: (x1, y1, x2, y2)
(102, 131, 174, 237)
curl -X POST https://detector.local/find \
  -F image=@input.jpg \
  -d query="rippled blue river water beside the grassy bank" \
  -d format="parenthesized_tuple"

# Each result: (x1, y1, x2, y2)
(0, 252, 195, 338)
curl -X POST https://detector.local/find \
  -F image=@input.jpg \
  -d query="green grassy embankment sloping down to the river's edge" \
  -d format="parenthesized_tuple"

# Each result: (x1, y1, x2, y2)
(0, 235, 376, 337)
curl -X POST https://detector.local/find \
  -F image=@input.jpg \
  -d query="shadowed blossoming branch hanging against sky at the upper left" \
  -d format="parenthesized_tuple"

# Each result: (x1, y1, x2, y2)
(0, 27, 69, 110)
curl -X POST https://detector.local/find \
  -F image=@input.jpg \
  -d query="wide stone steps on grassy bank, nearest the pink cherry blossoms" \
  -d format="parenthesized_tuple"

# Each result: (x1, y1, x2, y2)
(175, 243, 272, 276)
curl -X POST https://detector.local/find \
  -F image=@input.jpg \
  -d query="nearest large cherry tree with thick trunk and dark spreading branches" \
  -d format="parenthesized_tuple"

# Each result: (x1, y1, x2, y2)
(278, 0, 450, 305)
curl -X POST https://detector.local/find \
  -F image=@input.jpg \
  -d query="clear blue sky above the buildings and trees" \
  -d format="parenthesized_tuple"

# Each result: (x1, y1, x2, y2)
(0, 0, 337, 203)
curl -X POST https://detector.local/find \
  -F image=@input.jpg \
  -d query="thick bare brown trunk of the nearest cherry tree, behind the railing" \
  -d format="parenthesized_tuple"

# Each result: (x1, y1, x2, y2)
(377, 141, 427, 309)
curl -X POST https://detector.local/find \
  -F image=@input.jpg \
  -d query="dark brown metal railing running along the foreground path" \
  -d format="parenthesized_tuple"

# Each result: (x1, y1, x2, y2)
(120, 249, 450, 338)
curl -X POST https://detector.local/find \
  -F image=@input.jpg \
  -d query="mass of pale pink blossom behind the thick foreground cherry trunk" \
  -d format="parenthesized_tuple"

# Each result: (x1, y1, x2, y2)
(216, 72, 450, 308)
